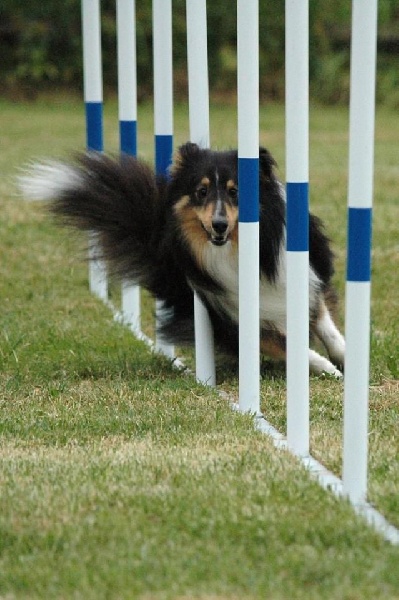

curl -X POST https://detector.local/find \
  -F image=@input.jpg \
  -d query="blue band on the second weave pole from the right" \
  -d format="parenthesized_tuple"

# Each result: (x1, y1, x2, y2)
(287, 182, 309, 252)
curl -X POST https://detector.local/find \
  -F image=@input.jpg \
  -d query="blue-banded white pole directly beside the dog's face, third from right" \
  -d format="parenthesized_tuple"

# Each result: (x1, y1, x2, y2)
(237, 0, 260, 414)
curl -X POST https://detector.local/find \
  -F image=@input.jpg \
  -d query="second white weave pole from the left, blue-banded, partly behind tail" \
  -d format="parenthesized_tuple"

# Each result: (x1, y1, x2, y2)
(116, 0, 141, 333)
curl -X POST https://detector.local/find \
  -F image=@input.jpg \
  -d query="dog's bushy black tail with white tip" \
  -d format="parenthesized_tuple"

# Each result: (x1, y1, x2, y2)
(20, 153, 165, 292)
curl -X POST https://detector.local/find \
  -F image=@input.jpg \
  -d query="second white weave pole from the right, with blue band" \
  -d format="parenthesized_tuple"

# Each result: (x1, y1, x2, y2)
(285, 0, 309, 456)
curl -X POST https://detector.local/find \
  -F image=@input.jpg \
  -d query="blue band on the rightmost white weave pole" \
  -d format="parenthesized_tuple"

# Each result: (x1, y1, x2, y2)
(346, 207, 372, 281)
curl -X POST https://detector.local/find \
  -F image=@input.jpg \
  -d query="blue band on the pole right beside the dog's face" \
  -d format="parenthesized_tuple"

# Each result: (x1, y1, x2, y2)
(238, 158, 259, 223)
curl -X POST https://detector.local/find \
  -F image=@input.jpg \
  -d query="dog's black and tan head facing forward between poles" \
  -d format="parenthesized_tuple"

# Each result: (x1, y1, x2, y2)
(171, 143, 238, 246)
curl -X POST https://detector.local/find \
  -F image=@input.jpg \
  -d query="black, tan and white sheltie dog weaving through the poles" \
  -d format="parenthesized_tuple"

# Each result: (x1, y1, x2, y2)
(22, 143, 345, 377)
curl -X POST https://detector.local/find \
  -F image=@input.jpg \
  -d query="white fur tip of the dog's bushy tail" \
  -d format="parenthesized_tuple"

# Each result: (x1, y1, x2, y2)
(17, 161, 81, 201)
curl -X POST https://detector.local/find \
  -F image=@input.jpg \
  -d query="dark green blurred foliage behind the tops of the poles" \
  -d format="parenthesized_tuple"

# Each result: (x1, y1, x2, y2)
(0, 0, 399, 106)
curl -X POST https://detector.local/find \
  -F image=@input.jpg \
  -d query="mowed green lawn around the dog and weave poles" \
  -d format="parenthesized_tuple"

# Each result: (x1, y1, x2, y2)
(0, 97, 399, 600)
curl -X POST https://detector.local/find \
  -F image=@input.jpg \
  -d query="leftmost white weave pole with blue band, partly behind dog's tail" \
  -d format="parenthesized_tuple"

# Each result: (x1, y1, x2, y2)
(82, 0, 108, 301)
